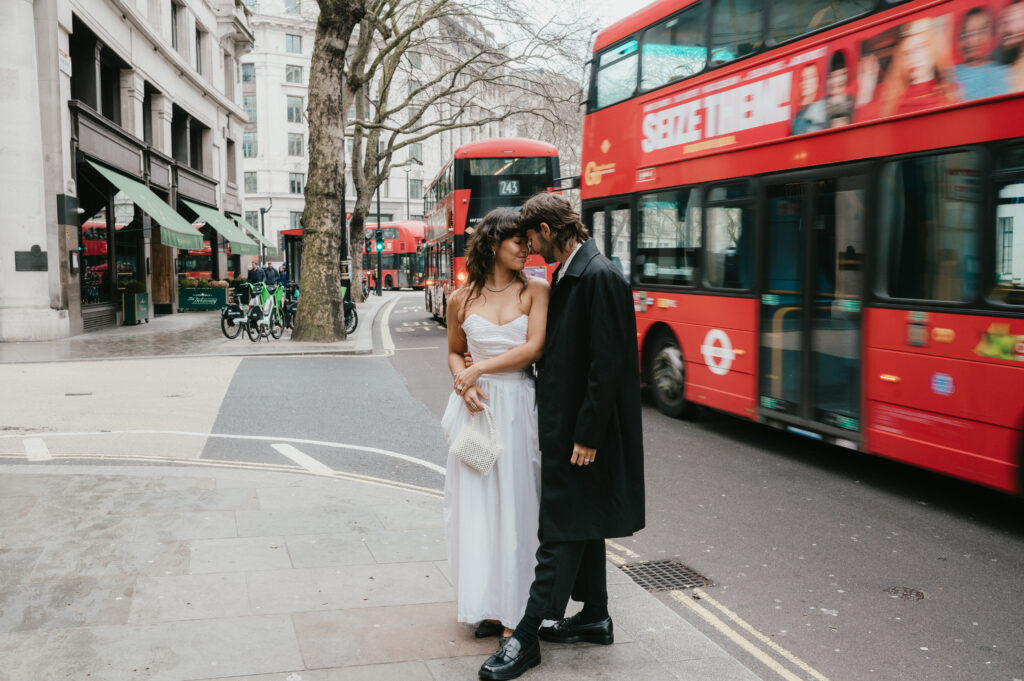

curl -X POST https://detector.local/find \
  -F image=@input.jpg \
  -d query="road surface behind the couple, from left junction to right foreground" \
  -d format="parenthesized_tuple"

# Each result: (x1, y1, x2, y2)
(0, 292, 1024, 681)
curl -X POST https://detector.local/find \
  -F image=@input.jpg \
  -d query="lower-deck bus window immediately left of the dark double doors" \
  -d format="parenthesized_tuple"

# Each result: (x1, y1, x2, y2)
(705, 182, 754, 290)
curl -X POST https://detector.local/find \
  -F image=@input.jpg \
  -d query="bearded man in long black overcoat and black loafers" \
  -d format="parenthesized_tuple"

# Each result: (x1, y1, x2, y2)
(479, 194, 644, 679)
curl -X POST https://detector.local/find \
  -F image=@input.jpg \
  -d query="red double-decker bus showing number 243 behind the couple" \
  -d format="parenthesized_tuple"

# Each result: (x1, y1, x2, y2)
(424, 138, 558, 320)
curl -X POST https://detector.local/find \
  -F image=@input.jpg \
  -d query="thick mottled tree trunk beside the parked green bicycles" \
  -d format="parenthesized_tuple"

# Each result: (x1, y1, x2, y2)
(292, 0, 366, 342)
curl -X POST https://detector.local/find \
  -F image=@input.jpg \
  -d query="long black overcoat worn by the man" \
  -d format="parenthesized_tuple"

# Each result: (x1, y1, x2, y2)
(537, 240, 644, 542)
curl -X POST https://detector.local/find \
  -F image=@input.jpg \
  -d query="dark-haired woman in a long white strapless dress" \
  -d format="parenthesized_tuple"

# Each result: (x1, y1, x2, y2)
(441, 208, 549, 638)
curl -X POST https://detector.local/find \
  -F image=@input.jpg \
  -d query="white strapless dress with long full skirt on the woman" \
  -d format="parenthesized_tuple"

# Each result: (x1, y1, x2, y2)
(441, 314, 541, 629)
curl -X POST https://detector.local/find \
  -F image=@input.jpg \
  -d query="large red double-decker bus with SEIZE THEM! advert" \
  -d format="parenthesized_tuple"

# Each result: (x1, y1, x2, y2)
(581, 0, 1024, 491)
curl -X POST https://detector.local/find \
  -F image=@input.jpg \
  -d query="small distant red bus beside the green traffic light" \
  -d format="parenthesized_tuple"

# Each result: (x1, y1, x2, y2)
(362, 220, 426, 291)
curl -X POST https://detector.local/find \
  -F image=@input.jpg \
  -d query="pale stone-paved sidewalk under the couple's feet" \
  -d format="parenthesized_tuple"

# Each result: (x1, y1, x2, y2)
(0, 464, 757, 681)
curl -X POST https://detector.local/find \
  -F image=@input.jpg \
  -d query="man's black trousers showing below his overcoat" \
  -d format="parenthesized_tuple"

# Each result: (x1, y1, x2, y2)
(526, 539, 608, 620)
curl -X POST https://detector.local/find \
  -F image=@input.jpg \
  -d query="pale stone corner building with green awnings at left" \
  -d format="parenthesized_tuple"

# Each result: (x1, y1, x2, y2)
(0, 0, 253, 341)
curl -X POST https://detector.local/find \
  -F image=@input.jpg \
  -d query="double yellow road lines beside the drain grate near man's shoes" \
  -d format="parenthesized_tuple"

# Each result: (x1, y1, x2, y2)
(605, 540, 828, 681)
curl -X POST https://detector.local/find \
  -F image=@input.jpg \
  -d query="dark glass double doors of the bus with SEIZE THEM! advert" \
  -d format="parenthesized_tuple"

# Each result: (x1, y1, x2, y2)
(759, 170, 866, 441)
